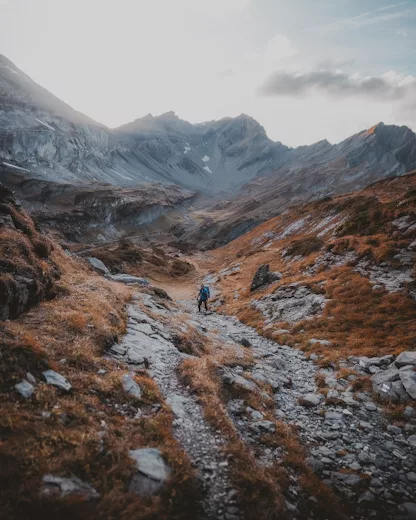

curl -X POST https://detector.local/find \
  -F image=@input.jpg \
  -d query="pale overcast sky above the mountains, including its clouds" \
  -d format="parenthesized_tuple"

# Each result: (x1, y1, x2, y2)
(0, 0, 416, 146)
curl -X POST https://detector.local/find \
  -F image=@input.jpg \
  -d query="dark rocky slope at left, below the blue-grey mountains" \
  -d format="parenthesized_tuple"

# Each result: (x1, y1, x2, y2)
(0, 170, 196, 244)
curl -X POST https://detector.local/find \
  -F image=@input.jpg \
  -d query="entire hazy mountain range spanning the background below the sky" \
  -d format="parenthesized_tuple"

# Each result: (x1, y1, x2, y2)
(0, 50, 416, 203)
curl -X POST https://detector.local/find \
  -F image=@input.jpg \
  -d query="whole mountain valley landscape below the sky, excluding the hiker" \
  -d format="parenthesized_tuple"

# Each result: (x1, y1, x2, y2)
(0, 49, 416, 520)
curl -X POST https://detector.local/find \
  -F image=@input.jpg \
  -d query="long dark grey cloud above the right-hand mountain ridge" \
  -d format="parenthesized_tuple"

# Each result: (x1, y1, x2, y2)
(260, 66, 416, 101)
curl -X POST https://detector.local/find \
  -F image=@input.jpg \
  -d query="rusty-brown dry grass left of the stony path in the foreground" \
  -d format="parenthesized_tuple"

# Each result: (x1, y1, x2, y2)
(0, 248, 199, 520)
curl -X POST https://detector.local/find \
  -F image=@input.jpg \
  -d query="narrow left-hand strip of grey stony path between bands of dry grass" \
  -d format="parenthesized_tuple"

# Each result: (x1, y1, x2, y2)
(111, 293, 235, 520)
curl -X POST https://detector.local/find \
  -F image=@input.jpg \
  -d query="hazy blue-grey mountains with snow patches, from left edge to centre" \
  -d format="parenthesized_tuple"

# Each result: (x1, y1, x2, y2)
(0, 56, 290, 194)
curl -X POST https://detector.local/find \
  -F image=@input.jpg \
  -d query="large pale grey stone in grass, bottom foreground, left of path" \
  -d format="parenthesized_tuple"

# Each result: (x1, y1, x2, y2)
(129, 448, 171, 496)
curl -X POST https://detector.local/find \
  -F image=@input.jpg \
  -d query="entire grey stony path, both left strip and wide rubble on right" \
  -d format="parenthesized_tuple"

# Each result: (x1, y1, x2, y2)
(112, 293, 416, 520)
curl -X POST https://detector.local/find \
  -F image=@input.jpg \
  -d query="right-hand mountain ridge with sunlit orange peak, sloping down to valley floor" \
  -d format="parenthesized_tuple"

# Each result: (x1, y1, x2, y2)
(181, 123, 416, 248)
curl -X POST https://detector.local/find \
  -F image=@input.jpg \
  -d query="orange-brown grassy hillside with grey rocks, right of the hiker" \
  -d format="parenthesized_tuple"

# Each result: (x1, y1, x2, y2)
(212, 172, 416, 362)
